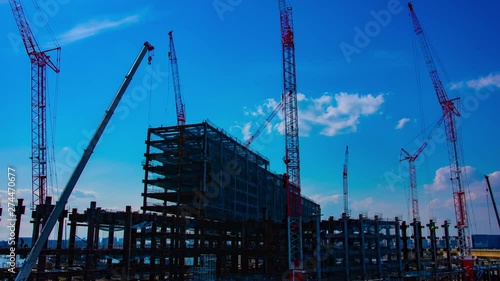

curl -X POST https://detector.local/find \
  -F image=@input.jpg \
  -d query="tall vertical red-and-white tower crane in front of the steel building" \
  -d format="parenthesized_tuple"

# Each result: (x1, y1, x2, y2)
(278, 0, 303, 280)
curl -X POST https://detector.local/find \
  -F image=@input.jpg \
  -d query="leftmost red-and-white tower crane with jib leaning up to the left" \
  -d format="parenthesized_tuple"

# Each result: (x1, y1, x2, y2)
(9, 0, 61, 209)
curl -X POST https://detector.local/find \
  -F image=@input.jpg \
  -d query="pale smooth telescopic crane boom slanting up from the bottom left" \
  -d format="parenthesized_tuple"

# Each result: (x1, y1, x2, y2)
(16, 42, 154, 281)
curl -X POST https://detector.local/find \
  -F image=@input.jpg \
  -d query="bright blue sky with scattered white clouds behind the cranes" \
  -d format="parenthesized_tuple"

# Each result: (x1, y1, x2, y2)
(0, 0, 500, 239)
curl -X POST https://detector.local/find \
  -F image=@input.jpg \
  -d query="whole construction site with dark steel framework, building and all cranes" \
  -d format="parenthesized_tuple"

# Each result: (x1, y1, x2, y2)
(0, 0, 500, 281)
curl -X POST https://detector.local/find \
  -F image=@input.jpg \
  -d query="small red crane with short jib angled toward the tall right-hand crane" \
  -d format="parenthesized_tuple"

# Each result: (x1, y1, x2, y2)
(399, 118, 444, 221)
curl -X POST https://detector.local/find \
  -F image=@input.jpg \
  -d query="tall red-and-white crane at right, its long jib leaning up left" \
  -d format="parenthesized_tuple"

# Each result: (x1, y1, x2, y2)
(408, 2, 471, 258)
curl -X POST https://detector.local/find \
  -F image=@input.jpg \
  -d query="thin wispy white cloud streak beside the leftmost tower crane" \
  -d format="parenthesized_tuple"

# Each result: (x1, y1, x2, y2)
(59, 15, 140, 44)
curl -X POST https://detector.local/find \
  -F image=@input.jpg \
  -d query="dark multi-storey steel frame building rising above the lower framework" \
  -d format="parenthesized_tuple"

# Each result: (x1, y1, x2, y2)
(142, 121, 320, 222)
